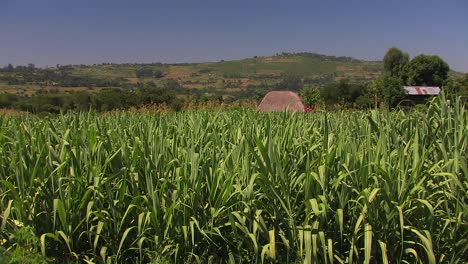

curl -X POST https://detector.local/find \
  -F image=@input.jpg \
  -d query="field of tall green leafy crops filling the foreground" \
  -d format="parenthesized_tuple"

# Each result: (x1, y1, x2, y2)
(0, 96, 468, 264)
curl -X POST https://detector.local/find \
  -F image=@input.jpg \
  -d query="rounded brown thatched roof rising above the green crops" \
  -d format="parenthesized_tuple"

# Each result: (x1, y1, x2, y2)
(258, 91, 305, 112)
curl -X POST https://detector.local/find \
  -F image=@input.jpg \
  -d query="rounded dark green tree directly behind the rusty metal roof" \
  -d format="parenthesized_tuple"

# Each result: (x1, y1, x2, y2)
(407, 54, 450, 86)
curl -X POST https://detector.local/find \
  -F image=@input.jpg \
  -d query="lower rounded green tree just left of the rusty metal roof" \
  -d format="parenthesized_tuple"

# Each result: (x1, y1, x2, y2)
(372, 75, 406, 108)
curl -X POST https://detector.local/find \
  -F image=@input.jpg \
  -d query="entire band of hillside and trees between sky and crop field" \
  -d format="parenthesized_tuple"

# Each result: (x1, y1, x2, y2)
(0, 50, 468, 113)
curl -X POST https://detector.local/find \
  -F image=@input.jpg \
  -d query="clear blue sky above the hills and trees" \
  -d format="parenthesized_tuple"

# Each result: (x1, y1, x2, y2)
(0, 0, 468, 72)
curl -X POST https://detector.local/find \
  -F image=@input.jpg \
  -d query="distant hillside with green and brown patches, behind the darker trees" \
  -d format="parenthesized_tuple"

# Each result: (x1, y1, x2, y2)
(0, 53, 382, 95)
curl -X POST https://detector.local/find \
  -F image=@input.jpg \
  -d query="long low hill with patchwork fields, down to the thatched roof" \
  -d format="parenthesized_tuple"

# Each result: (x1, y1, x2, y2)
(0, 52, 460, 99)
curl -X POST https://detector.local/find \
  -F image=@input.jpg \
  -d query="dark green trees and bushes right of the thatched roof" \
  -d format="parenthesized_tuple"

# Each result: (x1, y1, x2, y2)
(274, 47, 460, 108)
